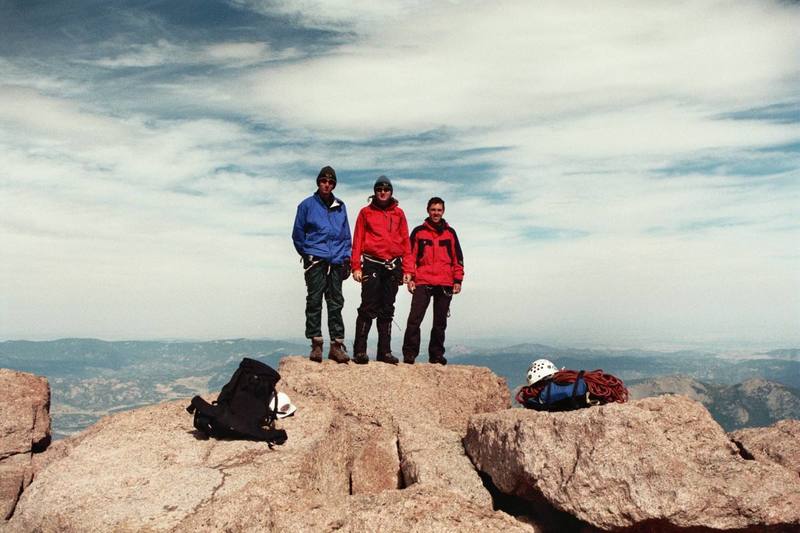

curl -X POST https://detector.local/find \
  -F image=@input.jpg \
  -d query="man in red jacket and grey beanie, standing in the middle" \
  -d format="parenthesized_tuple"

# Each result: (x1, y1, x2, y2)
(350, 176, 413, 365)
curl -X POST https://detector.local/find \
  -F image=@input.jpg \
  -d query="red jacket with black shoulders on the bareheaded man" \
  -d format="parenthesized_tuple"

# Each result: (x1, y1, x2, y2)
(411, 218, 464, 287)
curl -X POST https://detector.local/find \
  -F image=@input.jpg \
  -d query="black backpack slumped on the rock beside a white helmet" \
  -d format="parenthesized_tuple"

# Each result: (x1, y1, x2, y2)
(186, 357, 286, 447)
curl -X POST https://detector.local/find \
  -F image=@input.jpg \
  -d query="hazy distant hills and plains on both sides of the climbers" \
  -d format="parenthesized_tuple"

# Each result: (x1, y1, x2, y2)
(0, 339, 800, 438)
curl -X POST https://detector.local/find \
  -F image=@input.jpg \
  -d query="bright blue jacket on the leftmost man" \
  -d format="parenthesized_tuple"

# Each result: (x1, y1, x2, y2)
(292, 192, 352, 265)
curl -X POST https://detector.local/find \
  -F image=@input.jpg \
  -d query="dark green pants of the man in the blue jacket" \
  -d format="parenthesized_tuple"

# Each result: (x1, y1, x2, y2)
(305, 262, 344, 339)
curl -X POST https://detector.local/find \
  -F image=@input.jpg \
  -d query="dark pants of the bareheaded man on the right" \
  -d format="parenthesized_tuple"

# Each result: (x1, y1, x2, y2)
(403, 285, 453, 360)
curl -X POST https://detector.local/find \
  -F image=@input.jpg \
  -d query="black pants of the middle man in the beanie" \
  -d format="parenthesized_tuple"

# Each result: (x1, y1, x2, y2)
(353, 261, 403, 357)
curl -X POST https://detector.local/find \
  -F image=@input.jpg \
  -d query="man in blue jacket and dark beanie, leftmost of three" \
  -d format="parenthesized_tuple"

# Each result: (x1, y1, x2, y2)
(292, 166, 352, 363)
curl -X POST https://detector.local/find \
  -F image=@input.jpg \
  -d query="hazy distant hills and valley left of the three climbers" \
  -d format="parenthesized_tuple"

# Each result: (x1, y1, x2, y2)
(0, 339, 307, 438)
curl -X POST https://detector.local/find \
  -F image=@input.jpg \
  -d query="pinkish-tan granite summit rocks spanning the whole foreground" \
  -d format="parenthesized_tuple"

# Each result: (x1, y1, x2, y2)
(0, 357, 800, 533)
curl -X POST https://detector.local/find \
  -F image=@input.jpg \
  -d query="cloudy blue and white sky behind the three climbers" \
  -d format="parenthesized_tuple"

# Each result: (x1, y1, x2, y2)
(0, 0, 800, 351)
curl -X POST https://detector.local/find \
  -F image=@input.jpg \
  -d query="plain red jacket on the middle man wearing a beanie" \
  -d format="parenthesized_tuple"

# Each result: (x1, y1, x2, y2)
(350, 198, 414, 273)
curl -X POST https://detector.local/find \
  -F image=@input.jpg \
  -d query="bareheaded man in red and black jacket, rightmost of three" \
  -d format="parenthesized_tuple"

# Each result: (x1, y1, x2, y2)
(403, 196, 464, 365)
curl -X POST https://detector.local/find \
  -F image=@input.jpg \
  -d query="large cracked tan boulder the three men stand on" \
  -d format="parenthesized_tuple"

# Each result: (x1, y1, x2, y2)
(8, 357, 520, 532)
